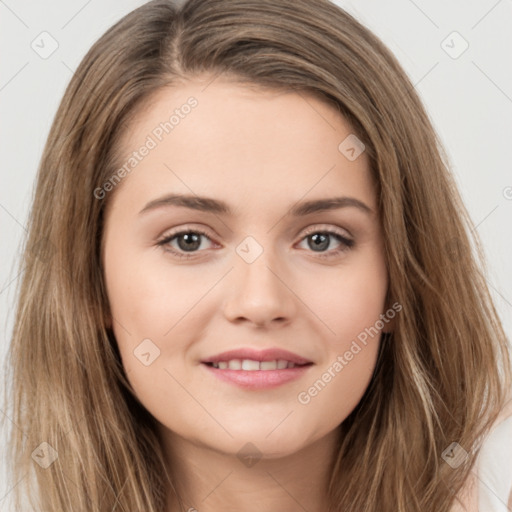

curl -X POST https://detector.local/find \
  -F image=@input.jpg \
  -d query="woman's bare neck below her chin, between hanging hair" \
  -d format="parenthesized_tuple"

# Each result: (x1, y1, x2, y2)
(163, 430, 338, 512)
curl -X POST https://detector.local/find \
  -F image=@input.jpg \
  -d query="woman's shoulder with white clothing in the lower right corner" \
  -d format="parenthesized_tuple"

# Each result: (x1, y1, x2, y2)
(450, 395, 512, 512)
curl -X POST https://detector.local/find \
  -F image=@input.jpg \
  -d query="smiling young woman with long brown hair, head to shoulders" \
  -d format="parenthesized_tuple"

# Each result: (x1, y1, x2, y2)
(5, 0, 512, 512)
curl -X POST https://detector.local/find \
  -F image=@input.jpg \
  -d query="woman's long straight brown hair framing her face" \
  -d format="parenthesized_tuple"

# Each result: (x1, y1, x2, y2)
(3, 0, 511, 512)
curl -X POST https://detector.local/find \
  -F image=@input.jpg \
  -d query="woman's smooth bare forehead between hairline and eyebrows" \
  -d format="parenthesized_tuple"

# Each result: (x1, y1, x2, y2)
(108, 78, 375, 217)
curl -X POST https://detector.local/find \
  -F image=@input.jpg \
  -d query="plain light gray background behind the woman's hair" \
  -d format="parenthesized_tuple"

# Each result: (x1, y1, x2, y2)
(0, 0, 512, 511)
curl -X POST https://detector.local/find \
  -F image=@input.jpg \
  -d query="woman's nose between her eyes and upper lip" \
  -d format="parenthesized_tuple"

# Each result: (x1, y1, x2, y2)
(223, 250, 296, 327)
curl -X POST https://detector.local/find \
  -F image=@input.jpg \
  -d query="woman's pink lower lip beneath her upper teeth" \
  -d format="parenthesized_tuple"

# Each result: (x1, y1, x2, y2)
(202, 363, 313, 389)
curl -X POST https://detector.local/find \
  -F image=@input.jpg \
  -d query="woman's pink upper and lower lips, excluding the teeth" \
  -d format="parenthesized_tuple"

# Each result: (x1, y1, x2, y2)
(201, 348, 314, 390)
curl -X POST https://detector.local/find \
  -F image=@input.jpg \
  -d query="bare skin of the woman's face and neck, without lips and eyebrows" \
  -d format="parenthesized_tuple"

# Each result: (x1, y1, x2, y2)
(102, 77, 392, 512)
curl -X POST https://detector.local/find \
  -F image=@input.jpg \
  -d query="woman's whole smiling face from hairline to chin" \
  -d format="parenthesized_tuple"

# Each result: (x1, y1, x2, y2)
(101, 78, 389, 458)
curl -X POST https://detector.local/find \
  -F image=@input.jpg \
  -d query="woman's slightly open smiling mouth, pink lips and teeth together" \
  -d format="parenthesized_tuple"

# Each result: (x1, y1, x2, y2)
(201, 349, 314, 389)
